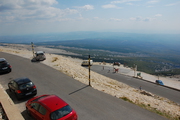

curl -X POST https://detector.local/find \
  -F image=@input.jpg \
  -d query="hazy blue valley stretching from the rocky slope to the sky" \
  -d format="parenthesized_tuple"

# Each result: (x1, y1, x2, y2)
(0, 32, 180, 75)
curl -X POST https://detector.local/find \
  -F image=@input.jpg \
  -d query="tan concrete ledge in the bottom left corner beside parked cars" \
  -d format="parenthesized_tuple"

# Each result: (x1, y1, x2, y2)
(0, 84, 24, 120)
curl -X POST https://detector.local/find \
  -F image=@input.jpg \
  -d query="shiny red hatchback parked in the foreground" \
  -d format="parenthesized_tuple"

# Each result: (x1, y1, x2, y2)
(26, 95, 77, 120)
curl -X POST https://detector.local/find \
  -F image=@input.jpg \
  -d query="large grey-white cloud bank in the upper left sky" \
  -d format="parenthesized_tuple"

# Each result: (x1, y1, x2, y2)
(0, 0, 78, 22)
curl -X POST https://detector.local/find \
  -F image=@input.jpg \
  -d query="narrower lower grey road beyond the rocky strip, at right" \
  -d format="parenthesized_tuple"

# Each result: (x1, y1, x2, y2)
(91, 65, 180, 104)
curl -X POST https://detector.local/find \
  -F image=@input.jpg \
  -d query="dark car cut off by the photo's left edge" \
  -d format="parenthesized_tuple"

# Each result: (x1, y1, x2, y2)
(0, 58, 11, 73)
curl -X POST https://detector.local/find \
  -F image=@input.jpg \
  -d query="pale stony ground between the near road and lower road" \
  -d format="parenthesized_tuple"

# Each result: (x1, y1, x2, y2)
(0, 44, 180, 120)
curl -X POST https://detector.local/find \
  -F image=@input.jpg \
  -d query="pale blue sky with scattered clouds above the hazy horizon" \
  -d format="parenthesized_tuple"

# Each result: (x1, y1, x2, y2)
(0, 0, 180, 36)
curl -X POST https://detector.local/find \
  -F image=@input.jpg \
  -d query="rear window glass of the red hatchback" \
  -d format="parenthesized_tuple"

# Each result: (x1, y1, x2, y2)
(50, 105, 72, 120)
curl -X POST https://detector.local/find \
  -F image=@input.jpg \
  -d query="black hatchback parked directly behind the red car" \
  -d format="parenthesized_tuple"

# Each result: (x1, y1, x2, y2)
(8, 77, 37, 100)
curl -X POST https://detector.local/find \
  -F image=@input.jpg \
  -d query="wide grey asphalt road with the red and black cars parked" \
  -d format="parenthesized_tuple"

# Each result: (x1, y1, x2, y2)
(0, 52, 169, 120)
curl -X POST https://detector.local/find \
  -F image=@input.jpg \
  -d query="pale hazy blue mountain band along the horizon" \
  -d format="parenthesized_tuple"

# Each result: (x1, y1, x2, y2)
(0, 32, 180, 45)
